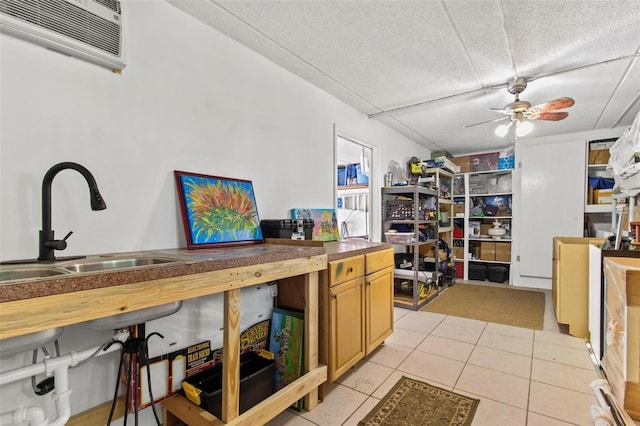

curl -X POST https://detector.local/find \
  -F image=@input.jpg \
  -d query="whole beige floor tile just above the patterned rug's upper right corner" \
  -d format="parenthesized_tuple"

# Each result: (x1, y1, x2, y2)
(454, 364, 529, 409)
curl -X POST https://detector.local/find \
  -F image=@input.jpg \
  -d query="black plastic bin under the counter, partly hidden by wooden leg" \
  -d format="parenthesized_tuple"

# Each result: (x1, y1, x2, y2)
(182, 352, 275, 419)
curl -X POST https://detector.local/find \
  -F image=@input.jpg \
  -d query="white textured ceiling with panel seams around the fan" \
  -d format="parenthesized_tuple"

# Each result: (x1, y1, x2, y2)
(169, 0, 640, 154)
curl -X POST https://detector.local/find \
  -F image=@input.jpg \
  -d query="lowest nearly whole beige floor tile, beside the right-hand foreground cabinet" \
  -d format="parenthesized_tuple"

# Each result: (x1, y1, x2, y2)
(529, 382, 597, 425)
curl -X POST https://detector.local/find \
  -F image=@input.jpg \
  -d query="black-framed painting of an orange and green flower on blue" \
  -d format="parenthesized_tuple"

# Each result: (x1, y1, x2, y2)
(173, 170, 264, 249)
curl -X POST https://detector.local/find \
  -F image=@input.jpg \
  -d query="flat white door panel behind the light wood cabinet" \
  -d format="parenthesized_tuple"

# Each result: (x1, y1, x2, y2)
(518, 140, 586, 278)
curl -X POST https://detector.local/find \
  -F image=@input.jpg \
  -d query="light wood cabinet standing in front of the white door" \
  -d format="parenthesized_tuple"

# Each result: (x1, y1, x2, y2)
(551, 237, 604, 338)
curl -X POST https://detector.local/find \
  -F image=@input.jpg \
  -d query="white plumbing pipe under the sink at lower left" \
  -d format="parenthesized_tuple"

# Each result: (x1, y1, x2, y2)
(0, 338, 121, 426)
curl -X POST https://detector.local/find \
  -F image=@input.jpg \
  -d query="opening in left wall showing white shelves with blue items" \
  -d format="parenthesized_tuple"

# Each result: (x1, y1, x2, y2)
(336, 134, 373, 240)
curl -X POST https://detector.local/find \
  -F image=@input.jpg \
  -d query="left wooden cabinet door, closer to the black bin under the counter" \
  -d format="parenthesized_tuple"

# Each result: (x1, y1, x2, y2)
(328, 277, 365, 383)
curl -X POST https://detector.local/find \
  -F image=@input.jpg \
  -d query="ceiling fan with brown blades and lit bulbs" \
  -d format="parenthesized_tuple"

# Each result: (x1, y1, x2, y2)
(464, 78, 575, 137)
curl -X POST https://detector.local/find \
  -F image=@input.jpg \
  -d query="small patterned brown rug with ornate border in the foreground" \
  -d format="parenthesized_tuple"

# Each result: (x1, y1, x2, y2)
(358, 376, 480, 426)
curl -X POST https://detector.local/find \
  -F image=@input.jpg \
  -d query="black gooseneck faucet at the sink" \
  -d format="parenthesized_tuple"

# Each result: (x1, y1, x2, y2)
(38, 162, 107, 261)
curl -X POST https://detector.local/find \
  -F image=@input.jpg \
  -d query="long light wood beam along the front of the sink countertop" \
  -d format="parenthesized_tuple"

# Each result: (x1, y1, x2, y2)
(0, 254, 327, 339)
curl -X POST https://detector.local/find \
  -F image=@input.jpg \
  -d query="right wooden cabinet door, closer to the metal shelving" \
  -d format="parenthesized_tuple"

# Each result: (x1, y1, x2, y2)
(365, 268, 393, 355)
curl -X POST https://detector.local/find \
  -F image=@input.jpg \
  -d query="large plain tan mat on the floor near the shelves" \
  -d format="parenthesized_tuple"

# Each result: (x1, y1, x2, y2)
(421, 283, 544, 330)
